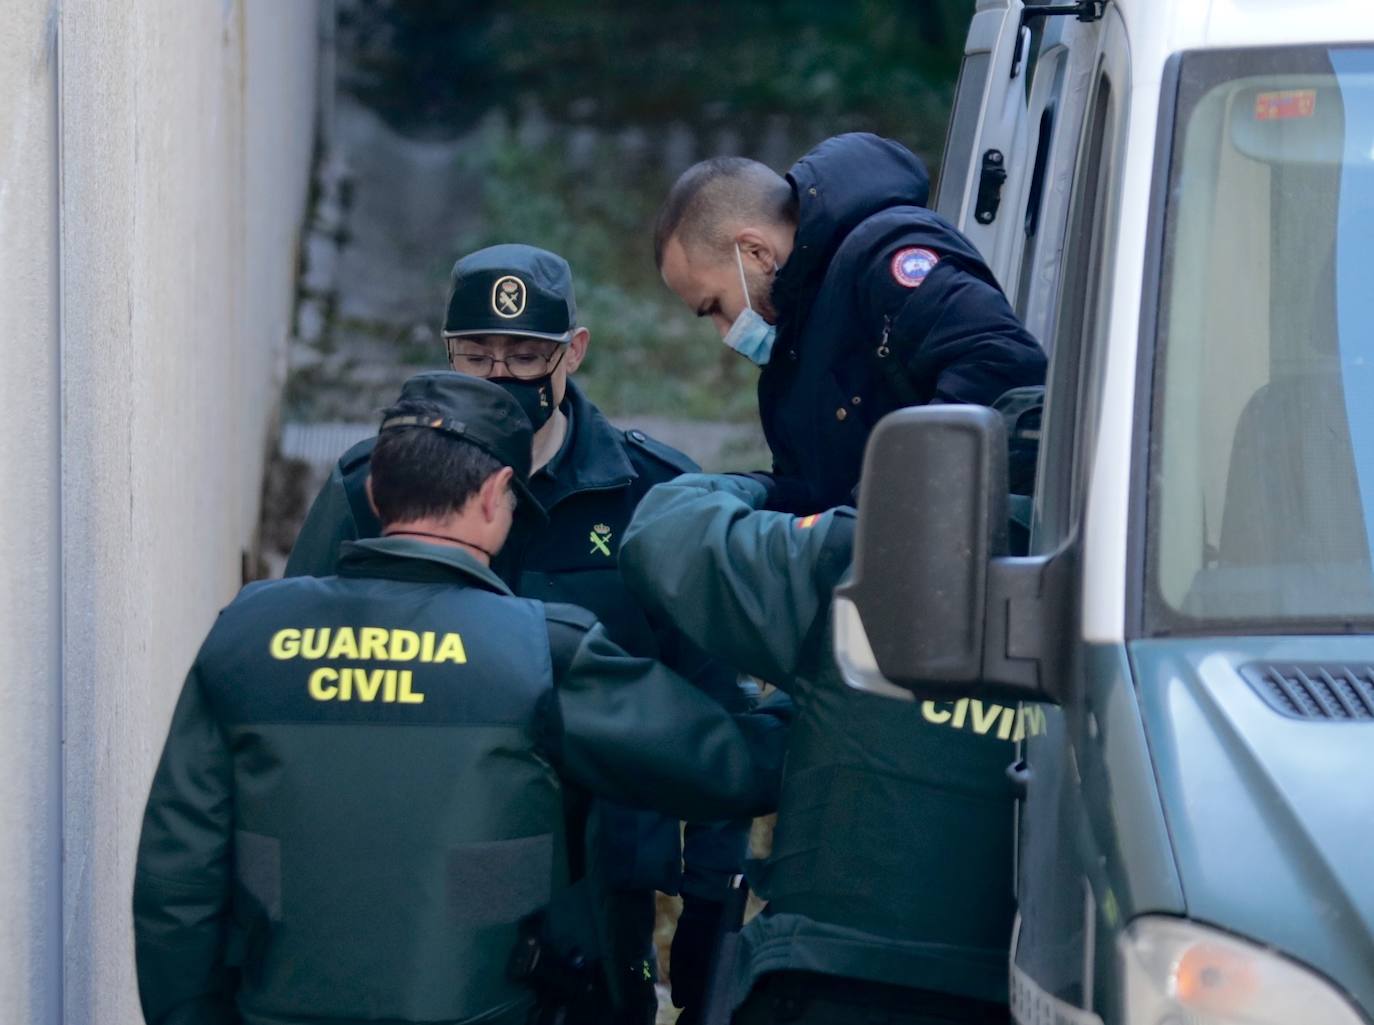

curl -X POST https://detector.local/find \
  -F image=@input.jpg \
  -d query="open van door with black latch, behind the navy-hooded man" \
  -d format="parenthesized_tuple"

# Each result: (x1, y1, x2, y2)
(934, 0, 1031, 284)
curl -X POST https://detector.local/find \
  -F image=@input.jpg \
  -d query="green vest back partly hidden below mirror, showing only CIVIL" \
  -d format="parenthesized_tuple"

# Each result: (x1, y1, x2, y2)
(752, 610, 1025, 999)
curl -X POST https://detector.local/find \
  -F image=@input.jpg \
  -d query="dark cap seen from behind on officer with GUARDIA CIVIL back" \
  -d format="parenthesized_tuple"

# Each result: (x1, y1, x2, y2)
(381, 370, 547, 519)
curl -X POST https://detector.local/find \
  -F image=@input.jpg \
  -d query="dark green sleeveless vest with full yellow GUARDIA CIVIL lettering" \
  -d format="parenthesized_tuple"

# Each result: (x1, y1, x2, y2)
(198, 576, 567, 1022)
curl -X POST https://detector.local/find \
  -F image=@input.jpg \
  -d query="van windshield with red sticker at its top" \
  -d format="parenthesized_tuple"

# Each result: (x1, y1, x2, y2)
(1149, 47, 1374, 631)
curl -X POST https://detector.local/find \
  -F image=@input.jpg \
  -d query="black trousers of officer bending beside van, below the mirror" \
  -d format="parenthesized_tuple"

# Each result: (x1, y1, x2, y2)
(731, 971, 1011, 1025)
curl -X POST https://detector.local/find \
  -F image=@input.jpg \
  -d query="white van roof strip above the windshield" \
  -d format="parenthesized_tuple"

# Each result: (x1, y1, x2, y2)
(1109, 0, 1374, 65)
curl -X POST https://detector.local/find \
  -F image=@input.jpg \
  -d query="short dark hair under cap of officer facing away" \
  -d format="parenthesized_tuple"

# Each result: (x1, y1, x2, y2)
(371, 400, 502, 526)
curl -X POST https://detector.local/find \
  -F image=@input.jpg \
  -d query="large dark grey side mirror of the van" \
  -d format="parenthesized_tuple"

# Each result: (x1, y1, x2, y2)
(833, 405, 1068, 701)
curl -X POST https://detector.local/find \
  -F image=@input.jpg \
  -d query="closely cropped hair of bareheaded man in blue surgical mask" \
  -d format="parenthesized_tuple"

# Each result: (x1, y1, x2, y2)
(654, 157, 797, 268)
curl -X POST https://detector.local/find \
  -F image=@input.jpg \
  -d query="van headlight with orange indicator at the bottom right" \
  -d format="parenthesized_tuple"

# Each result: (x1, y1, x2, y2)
(1117, 918, 1364, 1025)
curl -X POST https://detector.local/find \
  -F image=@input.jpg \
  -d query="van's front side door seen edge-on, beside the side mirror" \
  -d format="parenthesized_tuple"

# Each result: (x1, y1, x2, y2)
(1011, 7, 1131, 1025)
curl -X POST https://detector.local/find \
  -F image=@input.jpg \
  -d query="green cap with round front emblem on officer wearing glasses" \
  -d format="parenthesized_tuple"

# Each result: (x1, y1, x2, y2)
(444, 245, 577, 342)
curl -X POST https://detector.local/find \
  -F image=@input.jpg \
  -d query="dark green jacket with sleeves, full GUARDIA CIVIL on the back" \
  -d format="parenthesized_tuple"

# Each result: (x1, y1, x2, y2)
(133, 539, 780, 1025)
